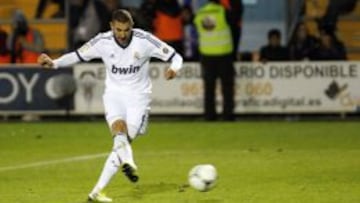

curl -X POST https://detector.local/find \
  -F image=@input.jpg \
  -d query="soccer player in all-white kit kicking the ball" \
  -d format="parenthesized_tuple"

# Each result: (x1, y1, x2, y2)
(38, 9, 183, 202)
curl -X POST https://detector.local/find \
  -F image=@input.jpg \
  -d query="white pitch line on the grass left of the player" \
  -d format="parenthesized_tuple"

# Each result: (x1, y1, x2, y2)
(0, 153, 109, 172)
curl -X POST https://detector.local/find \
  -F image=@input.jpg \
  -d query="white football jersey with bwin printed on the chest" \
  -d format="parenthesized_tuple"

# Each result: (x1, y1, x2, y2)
(76, 29, 175, 94)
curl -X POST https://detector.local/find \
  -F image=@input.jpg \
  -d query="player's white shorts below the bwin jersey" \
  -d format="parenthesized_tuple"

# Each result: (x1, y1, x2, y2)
(103, 92, 151, 139)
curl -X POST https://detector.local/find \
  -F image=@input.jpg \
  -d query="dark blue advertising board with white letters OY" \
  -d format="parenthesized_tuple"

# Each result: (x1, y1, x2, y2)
(0, 67, 74, 112)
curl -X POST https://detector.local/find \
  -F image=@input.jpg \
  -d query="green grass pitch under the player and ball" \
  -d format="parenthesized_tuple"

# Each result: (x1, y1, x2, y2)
(0, 121, 360, 203)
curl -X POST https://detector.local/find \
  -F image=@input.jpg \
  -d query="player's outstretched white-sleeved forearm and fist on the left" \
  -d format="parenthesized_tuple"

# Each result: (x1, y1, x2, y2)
(38, 52, 80, 69)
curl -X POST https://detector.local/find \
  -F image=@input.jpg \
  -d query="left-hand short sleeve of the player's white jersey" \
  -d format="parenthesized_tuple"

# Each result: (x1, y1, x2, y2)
(75, 34, 101, 61)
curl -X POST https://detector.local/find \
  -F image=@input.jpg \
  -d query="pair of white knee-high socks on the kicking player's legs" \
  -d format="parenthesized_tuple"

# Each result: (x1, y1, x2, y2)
(90, 133, 137, 196)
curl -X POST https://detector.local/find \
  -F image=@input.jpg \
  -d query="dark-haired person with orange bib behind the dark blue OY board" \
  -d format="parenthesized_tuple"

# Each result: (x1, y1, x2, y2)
(8, 10, 44, 63)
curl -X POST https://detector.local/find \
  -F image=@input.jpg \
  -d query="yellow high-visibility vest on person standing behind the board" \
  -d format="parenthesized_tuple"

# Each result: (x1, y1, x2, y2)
(194, 2, 233, 55)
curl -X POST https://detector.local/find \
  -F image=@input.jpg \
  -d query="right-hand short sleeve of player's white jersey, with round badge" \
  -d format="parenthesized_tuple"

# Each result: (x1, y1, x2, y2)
(148, 34, 176, 61)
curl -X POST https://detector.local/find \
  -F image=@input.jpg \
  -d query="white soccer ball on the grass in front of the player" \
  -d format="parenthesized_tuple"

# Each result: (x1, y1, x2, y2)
(189, 164, 217, 192)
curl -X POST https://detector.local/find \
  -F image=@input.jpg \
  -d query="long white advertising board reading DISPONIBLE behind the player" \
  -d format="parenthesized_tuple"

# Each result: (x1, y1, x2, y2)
(74, 62, 360, 114)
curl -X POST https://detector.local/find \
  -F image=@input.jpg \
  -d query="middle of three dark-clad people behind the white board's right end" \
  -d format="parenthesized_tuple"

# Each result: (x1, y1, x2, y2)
(288, 22, 319, 61)
